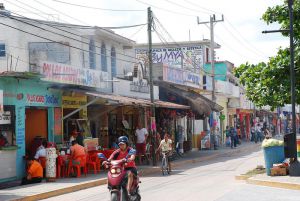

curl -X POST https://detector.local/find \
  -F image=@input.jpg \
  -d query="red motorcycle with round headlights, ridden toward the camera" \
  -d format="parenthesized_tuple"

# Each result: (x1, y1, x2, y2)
(98, 150, 141, 201)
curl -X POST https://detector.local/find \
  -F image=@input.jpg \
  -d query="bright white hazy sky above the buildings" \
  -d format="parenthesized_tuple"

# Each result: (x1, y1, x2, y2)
(0, 0, 289, 66)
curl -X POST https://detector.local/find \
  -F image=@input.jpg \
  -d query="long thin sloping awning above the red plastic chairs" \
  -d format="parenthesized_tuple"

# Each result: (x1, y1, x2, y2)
(85, 92, 190, 109)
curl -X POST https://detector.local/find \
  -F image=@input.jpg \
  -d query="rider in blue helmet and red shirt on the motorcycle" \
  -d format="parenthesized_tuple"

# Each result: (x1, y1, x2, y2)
(103, 136, 137, 194)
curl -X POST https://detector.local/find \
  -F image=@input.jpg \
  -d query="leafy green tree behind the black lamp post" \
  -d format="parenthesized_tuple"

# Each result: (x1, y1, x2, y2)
(235, 0, 300, 109)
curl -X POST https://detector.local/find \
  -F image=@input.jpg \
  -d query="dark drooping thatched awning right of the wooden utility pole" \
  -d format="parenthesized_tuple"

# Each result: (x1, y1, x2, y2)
(161, 85, 223, 116)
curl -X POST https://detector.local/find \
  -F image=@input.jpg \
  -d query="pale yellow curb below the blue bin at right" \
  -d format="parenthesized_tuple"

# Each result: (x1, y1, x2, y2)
(246, 178, 300, 190)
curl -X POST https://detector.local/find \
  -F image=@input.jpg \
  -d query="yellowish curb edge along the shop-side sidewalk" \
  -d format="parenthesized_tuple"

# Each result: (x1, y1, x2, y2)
(11, 146, 258, 201)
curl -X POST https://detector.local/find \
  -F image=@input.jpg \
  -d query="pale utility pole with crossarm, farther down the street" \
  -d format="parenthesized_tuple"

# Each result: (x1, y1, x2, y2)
(197, 15, 224, 138)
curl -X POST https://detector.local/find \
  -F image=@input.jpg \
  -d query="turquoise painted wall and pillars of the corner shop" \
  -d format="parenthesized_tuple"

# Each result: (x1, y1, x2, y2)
(0, 78, 61, 178)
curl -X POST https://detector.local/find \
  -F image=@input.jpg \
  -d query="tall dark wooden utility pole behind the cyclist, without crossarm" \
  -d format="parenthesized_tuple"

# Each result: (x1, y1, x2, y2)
(148, 7, 156, 166)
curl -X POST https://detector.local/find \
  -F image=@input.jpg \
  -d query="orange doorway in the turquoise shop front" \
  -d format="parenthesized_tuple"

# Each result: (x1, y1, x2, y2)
(25, 108, 48, 156)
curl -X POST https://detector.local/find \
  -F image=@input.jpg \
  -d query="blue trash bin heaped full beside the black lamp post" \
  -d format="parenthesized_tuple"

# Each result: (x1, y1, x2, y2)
(263, 146, 285, 175)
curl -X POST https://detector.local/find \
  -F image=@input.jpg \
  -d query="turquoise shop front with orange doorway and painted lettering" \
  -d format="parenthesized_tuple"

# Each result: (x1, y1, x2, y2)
(0, 74, 61, 182)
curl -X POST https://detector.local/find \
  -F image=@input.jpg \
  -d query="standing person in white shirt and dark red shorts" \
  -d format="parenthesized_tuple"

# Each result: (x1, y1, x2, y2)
(135, 123, 148, 164)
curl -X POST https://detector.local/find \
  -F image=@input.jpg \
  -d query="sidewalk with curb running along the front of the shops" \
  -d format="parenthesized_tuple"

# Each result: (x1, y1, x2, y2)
(0, 143, 260, 201)
